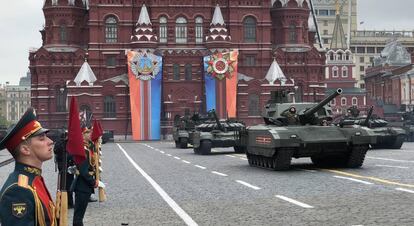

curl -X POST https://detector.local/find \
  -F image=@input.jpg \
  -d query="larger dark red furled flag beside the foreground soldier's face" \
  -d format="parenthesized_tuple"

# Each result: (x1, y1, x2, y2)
(66, 97, 86, 164)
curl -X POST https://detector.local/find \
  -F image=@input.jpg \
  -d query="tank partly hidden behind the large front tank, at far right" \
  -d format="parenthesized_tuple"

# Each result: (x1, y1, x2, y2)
(339, 106, 406, 149)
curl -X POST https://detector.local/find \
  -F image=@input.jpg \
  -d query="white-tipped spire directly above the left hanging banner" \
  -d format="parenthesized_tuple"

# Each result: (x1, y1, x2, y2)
(131, 4, 158, 43)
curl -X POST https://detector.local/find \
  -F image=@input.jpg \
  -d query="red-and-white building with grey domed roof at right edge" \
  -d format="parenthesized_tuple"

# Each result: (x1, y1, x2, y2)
(364, 40, 414, 120)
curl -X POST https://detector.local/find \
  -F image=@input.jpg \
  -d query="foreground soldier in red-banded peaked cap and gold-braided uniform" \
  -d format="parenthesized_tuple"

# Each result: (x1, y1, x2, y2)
(0, 108, 57, 226)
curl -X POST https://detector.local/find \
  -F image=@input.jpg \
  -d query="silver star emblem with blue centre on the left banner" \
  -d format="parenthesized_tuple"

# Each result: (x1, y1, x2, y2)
(131, 52, 160, 81)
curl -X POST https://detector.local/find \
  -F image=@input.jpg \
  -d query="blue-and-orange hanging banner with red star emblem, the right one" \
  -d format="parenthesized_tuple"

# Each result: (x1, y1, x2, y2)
(204, 50, 239, 118)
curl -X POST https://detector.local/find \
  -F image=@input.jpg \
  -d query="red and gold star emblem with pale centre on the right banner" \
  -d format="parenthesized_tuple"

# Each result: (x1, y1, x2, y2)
(207, 53, 236, 80)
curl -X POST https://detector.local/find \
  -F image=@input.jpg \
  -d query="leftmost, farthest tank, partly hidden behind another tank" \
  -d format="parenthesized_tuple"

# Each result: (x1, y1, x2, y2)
(173, 111, 209, 148)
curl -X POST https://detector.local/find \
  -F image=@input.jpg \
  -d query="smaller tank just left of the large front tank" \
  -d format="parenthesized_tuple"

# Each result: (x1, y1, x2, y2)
(193, 110, 246, 155)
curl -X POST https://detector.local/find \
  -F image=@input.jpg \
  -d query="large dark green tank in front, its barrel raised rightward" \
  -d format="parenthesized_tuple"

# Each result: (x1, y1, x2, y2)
(242, 89, 376, 170)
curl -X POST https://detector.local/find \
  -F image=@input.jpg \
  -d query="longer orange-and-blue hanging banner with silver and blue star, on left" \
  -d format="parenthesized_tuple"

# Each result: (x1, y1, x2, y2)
(128, 51, 162, 140)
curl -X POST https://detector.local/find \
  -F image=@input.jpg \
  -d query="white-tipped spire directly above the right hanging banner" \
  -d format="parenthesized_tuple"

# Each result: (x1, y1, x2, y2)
(206, 4, 231, 43)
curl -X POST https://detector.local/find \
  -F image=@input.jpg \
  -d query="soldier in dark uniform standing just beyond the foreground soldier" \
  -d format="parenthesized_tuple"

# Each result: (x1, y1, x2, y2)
(73, 127, 98, 226)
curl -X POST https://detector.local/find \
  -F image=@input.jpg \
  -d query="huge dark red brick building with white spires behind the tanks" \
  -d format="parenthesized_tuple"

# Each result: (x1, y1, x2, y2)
(29, 0, 326, 139)
